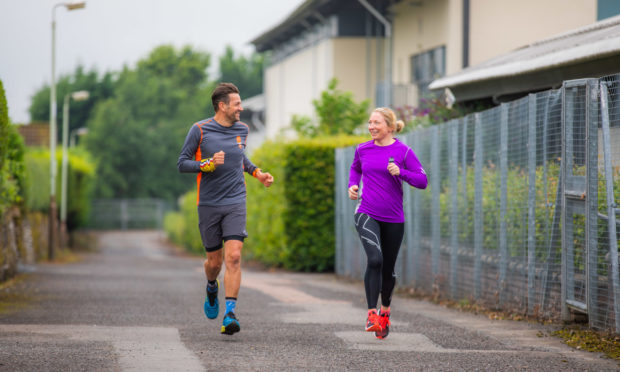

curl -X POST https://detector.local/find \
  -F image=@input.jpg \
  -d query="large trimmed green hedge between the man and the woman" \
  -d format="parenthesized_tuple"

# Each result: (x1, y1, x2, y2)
(246, 136, 367, 271)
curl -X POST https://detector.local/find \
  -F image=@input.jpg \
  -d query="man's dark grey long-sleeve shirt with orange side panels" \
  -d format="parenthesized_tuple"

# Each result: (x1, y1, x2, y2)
(177, 118, 258, 206)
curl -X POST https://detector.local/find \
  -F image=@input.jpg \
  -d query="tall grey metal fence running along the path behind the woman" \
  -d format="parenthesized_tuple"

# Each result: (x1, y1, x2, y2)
(336, 75, 620, 332)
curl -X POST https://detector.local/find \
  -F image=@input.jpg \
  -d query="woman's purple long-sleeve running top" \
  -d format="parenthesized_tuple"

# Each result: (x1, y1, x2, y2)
(349, 139, 428, 223)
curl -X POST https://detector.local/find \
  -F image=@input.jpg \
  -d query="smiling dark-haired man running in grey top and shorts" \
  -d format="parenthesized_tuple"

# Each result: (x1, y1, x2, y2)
(177, 83, 273, 335)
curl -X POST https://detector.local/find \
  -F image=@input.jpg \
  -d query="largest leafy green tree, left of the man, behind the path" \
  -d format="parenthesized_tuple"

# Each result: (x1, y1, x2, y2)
(86, 45, 213, 200)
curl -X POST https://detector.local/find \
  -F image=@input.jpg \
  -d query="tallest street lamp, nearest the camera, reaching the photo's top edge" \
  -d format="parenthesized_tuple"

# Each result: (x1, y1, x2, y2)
(48, 1, 86, 260)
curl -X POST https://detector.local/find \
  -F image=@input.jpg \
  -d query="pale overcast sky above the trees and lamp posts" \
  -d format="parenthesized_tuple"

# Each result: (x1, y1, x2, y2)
(0, 0, 303, 123)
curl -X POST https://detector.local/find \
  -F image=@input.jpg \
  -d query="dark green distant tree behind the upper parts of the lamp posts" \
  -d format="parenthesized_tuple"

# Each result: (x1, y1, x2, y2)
(29, 66, 114, 139)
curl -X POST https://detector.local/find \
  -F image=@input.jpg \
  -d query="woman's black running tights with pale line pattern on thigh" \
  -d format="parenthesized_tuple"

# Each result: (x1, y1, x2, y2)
(355, 213, 405, 309)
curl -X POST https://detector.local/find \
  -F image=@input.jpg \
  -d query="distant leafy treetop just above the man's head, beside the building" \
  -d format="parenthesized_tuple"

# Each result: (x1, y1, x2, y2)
(218, 46, 265, 98)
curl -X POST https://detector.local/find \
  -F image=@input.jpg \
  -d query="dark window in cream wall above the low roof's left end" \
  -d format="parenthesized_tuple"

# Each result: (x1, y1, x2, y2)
(411, 46, 446, 99)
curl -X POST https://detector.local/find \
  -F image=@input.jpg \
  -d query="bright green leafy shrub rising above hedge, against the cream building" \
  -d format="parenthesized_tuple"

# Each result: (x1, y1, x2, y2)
(291, 78, 370, 137)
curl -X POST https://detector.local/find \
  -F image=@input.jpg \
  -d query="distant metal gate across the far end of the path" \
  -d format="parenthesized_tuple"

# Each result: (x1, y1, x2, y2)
(87, 199, 170, 230)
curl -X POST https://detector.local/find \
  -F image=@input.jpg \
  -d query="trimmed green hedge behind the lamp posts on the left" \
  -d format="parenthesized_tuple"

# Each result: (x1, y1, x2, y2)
(25, 147, 95, 230)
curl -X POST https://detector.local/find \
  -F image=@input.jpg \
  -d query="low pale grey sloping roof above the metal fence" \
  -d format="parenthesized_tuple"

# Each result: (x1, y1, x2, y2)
(429, 16, 620, 101)
